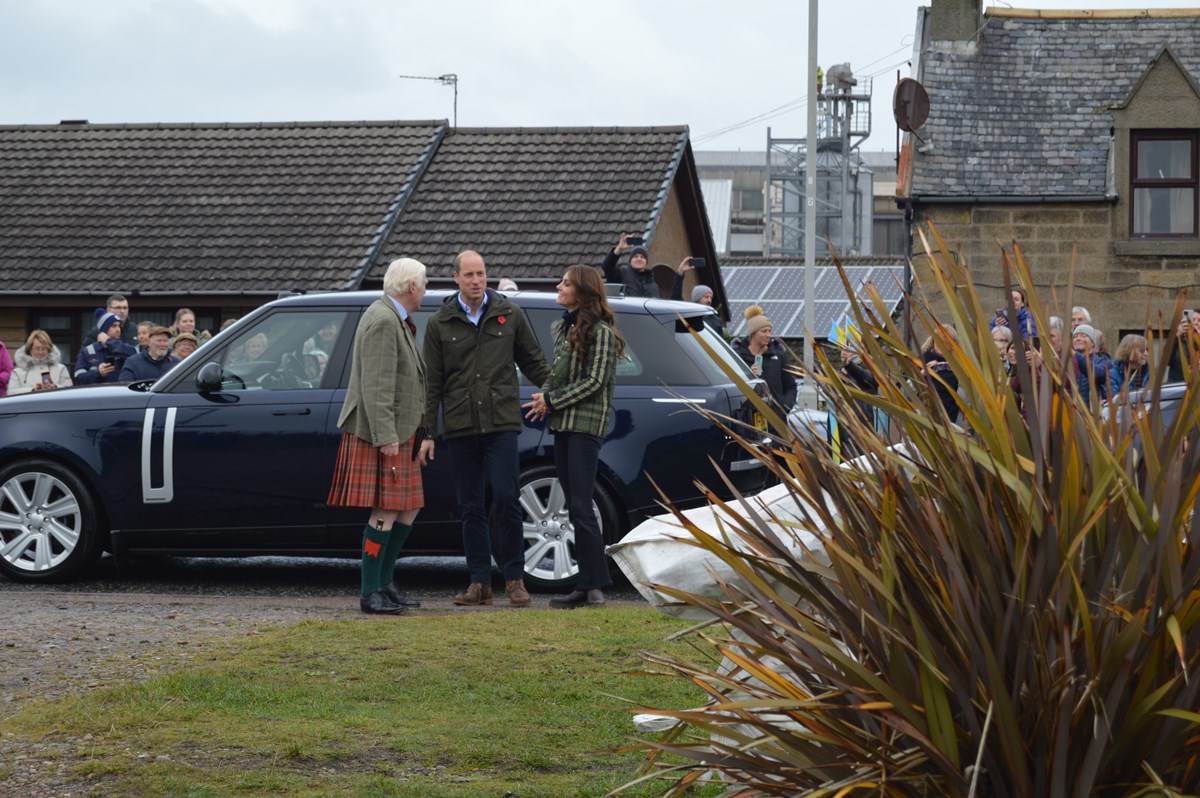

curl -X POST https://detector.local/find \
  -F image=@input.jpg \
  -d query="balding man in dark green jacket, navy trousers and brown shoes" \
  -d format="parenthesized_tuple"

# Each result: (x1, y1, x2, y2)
(421, 250, 550, 607)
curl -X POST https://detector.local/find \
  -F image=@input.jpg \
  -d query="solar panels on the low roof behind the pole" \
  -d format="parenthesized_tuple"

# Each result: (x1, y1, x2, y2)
(721, 263, 904, 338)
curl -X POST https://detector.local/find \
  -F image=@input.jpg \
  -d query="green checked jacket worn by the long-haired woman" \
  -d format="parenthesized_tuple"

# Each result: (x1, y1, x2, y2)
(542, 318, 617, 438)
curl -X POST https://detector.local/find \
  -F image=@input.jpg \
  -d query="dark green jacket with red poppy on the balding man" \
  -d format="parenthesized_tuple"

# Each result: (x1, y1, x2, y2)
(422, 289, 550, 440)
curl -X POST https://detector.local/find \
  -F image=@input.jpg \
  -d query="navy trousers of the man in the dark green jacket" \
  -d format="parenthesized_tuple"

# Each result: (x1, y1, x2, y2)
(446, 432, 524, 584)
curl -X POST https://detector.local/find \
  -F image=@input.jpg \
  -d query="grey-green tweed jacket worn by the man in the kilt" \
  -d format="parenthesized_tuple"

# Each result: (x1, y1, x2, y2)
(337, 296, 425, 449)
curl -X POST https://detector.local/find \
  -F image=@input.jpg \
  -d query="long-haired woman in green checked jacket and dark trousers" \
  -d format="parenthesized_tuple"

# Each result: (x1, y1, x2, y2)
(527, 265, 625, 610)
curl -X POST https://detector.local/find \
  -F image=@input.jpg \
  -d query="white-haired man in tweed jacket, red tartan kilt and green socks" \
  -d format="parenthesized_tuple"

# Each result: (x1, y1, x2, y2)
(328, 258, 426, 614)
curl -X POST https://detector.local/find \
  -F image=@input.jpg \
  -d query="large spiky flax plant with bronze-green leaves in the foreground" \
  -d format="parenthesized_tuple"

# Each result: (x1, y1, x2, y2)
(614, 228, 1200, 798)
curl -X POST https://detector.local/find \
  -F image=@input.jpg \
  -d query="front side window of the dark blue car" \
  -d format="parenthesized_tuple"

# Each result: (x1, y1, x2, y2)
(217, 308, 352, 391)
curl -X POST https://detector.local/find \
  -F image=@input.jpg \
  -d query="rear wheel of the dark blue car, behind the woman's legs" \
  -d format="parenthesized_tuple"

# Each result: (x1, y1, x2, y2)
(521, 466, 617, 592)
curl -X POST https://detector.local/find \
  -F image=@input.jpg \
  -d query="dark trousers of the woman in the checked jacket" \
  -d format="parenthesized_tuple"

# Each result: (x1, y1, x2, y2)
(554, 432, 612, 590)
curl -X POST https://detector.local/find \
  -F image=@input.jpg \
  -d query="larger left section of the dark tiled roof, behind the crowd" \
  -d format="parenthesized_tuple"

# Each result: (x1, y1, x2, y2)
(0, 121, 445, 293)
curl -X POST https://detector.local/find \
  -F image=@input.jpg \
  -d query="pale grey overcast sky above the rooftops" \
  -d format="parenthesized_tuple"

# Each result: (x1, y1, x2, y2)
(0, 0, 1196, 150)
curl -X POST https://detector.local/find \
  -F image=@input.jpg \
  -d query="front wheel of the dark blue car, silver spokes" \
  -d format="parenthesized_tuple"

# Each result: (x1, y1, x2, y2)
(0, 460, 100, 582)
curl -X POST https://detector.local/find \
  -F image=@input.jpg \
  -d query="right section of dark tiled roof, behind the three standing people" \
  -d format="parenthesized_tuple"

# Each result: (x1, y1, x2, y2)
(366, 127, 688, 284)
